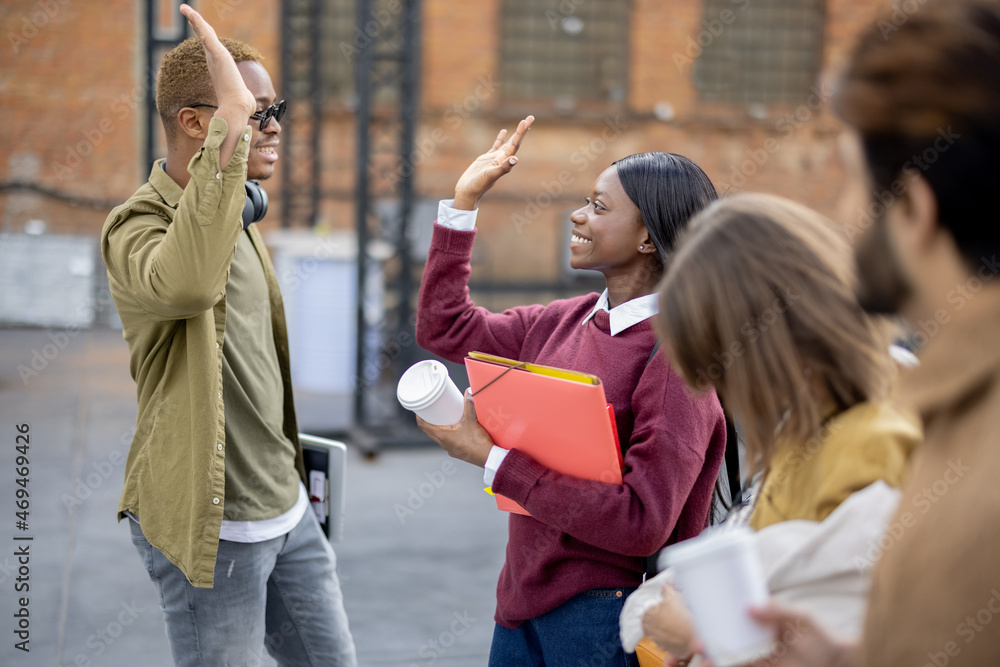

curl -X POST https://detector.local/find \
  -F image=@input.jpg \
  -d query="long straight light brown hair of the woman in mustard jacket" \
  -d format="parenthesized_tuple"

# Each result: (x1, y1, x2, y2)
(655, 194, 893, 470)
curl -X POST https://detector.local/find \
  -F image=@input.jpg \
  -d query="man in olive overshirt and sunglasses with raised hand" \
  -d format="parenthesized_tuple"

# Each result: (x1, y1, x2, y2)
(101, 5, 357, 667)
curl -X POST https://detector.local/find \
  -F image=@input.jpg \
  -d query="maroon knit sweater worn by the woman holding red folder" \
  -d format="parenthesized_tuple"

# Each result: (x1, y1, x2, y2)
(417, 224, 726, 628)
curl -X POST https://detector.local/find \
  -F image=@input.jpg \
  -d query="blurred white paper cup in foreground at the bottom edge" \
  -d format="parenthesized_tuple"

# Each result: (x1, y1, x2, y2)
(659, 528, 773, 667)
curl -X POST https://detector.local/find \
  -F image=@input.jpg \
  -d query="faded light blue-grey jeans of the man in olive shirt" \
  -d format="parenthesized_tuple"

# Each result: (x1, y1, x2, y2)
(129, 508, 357, 667)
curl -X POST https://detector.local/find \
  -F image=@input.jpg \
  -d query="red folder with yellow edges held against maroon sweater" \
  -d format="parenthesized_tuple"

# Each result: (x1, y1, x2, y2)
(465, 352, 622, 516)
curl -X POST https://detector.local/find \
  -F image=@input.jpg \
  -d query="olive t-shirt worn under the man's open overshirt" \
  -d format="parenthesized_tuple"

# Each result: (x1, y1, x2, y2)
(222, 232, 299, 521)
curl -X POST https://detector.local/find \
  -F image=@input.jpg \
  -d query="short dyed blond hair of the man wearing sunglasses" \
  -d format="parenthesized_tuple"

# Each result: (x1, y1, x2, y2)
(156, 37, 264, 138)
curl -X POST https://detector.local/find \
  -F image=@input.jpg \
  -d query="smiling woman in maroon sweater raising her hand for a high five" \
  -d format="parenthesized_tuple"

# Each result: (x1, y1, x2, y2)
(417, 116, 726, 665)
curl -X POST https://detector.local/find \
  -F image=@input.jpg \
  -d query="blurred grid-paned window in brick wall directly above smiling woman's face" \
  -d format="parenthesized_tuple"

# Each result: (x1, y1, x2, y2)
(500, 0, 629, 110)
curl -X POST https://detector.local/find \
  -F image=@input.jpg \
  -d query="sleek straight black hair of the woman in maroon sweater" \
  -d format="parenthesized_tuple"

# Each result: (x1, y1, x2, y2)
(612, 153, 719, 266)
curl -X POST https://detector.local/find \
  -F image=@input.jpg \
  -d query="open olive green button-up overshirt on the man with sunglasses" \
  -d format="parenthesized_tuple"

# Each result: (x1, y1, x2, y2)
(101, 118, 305, 588)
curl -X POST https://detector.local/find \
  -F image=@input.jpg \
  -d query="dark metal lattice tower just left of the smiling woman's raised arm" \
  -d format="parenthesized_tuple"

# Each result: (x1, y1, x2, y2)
(354, 0, 420, 436)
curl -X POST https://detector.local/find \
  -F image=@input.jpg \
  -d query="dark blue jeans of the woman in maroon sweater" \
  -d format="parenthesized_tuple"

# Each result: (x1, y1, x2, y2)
(489, 588, 639, 667)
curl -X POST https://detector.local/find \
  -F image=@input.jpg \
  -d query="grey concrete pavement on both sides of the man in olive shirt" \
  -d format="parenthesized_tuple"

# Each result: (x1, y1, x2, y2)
(0, 329, 506, 667)
